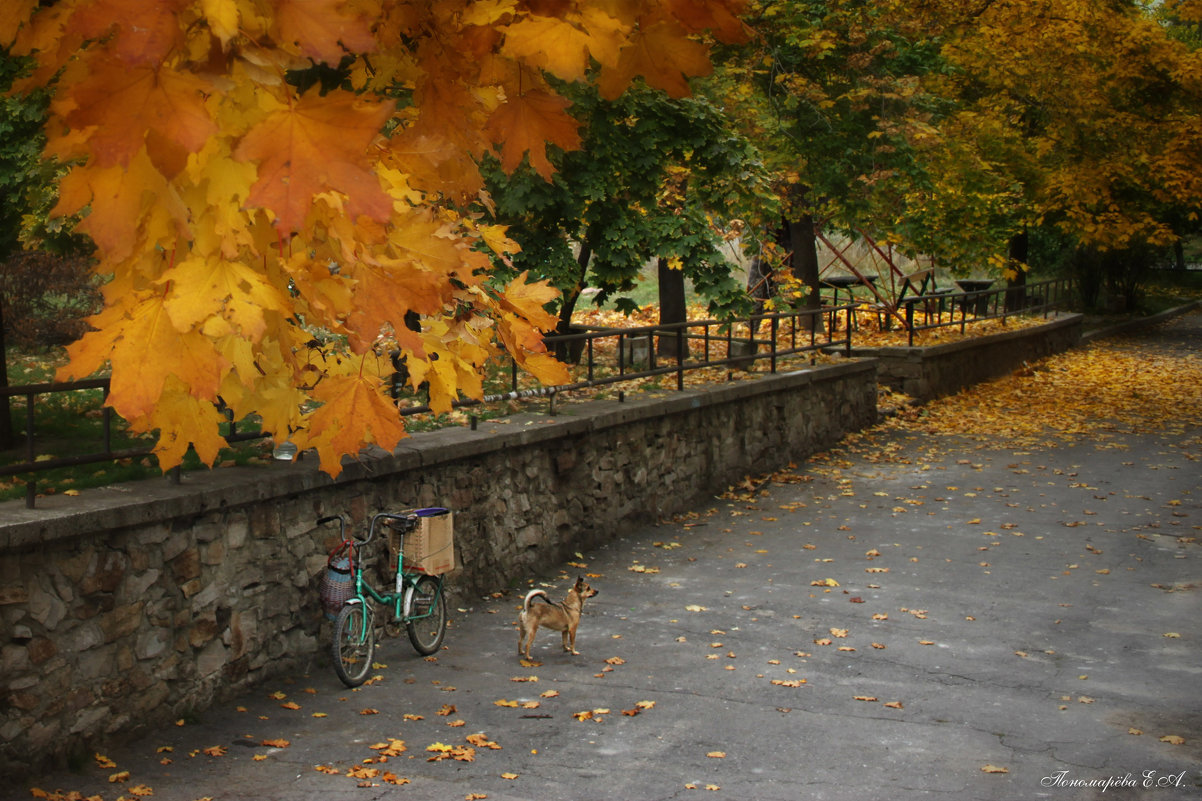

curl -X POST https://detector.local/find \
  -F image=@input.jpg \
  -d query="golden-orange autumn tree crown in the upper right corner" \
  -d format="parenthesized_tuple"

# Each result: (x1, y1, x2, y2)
(923, 0, 1202, 305)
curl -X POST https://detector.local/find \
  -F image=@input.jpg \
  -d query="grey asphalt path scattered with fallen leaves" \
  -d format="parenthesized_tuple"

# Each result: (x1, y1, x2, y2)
(18, 314, 1202, 801)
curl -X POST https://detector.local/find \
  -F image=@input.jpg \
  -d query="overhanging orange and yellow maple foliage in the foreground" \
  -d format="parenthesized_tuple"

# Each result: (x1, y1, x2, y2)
(0, 0, 743, 475)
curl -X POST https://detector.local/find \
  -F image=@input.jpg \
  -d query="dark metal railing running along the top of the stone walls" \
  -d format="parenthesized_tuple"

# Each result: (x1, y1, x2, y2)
(0, 279, 1072, 508)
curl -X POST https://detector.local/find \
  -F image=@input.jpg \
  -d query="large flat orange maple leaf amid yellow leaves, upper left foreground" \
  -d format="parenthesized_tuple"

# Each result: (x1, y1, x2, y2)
(233, 91, 393, 236)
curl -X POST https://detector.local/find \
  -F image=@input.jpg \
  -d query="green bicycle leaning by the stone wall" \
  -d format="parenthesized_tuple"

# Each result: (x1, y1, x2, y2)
(317, 509, 447, 687)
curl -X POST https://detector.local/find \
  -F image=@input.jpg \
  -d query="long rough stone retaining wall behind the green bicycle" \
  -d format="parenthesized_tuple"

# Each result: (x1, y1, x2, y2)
(0, 361, 876, 773)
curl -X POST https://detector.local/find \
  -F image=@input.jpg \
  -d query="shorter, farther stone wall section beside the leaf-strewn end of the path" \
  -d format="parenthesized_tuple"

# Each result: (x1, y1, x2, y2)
(853, 314, 1083, 402)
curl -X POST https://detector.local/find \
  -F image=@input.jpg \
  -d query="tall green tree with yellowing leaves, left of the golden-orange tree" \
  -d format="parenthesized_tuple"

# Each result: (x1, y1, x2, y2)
(715, 0, 941, 315)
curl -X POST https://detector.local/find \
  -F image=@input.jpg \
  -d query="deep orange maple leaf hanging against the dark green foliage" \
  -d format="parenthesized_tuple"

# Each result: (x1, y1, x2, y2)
(488, 89, 581, 180)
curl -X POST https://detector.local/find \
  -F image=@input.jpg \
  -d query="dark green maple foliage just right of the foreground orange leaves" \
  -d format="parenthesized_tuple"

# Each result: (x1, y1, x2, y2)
(484, 81, 763, 324)
